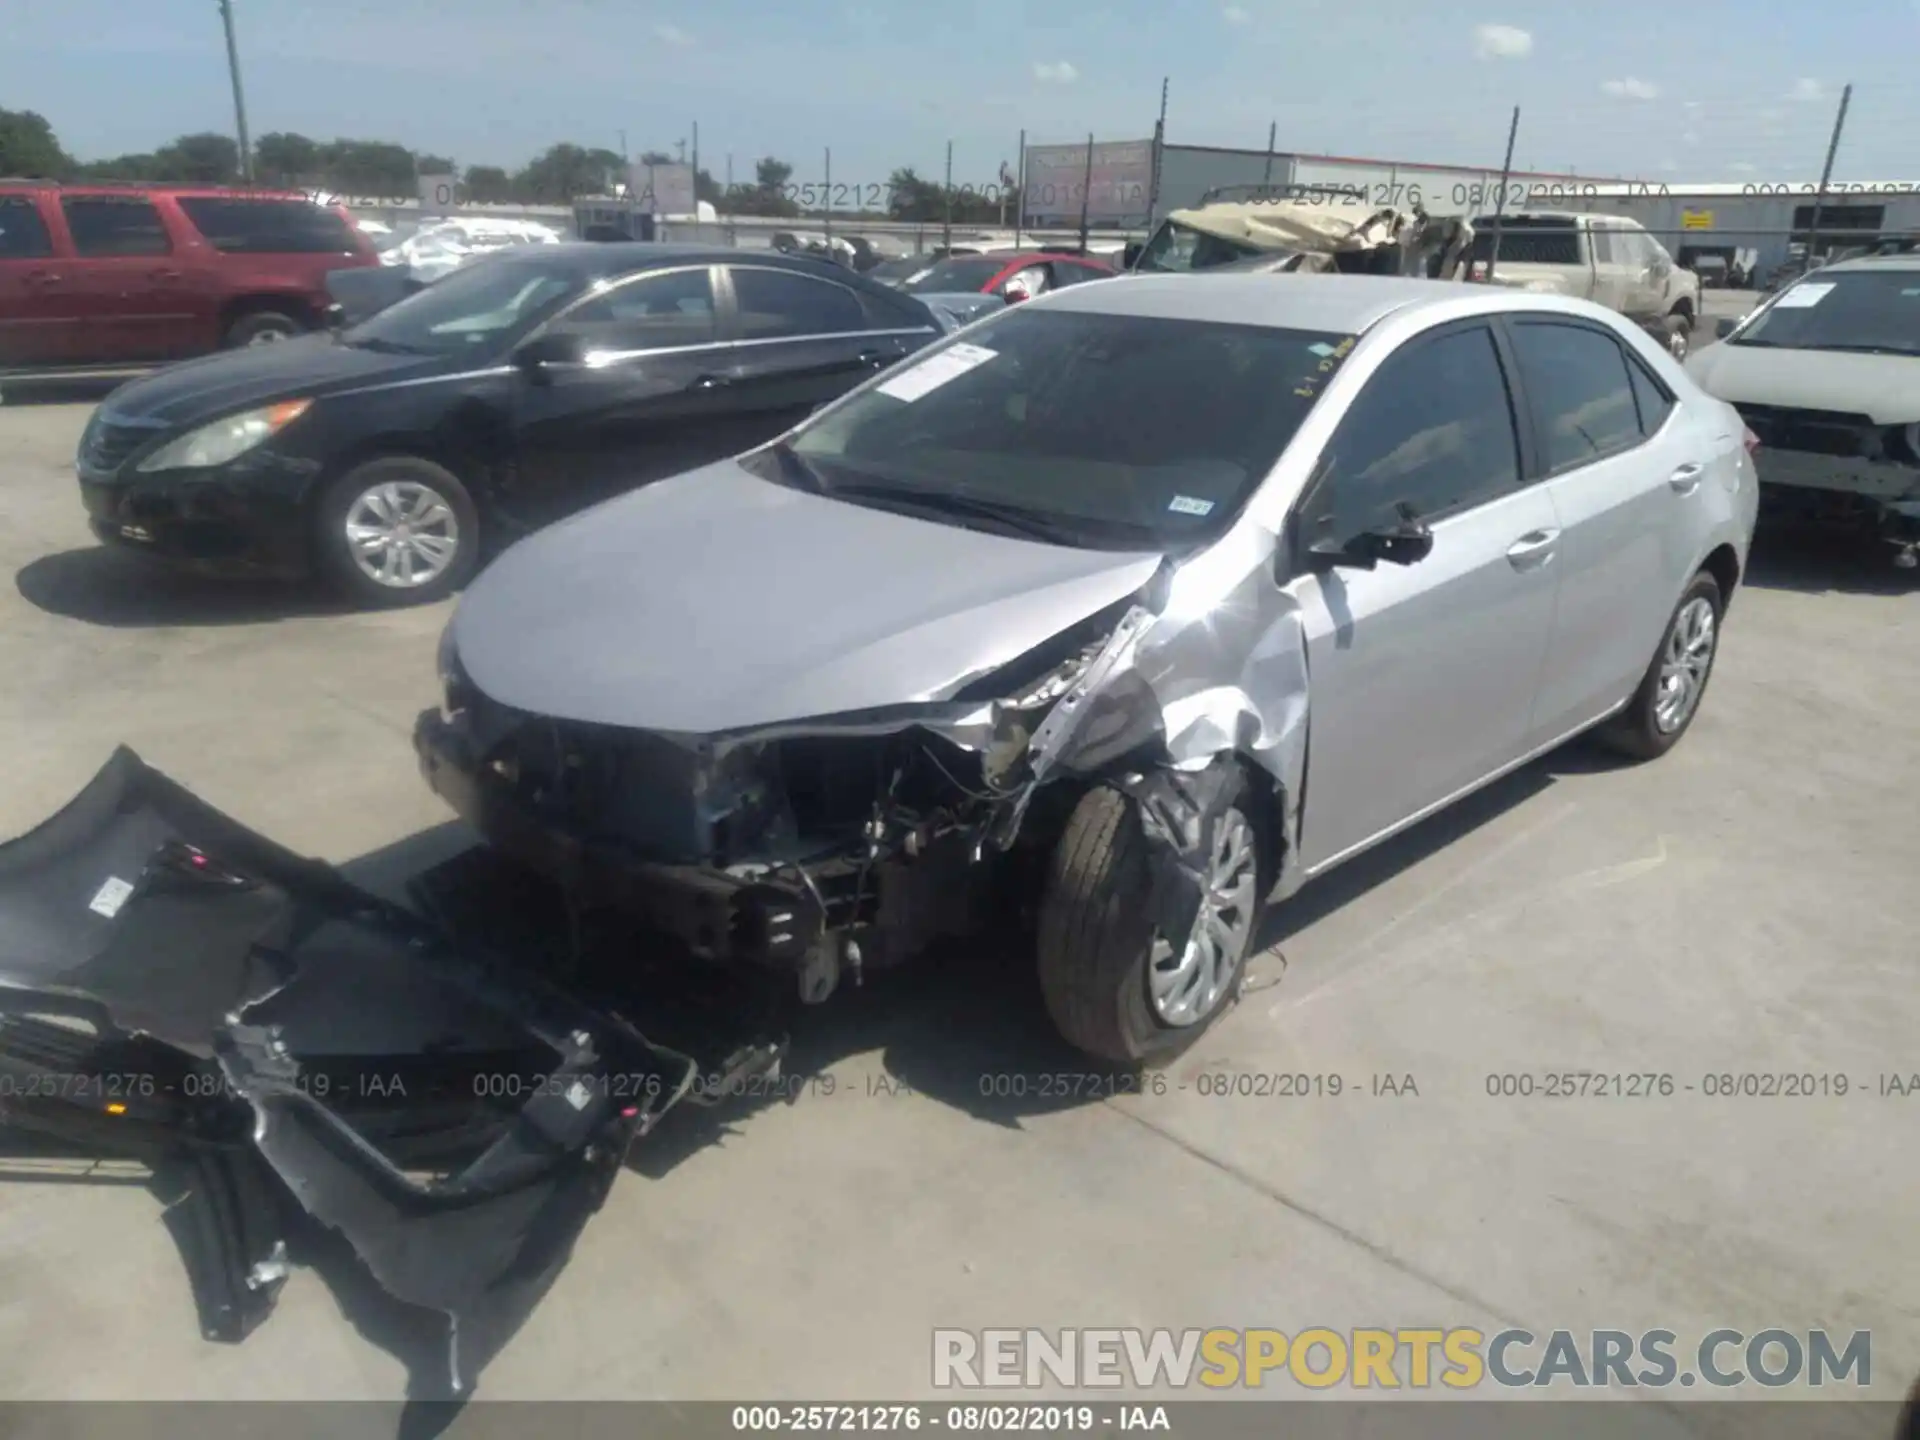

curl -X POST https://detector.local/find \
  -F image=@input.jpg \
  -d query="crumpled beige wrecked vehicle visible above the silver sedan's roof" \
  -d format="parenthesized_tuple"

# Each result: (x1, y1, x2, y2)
(1125, 184, 1473, 280)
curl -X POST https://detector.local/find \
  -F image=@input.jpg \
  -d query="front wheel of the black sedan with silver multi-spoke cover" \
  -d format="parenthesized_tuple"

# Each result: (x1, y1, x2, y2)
(317, 455, 480, 607)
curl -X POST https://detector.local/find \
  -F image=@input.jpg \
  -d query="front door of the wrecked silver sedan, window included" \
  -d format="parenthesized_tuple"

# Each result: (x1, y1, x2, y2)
(1288, 321, 1559, 874)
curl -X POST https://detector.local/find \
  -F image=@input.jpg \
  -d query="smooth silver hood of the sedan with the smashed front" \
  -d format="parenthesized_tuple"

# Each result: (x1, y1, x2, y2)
(453, 461, 1162, 735)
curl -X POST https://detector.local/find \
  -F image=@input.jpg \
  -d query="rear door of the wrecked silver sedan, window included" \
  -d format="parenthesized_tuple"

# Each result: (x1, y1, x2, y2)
(1507, 315, 1704, 745)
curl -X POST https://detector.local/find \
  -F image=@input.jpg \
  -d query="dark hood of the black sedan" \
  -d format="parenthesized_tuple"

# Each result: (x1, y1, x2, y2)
(106, 334, 451, 424)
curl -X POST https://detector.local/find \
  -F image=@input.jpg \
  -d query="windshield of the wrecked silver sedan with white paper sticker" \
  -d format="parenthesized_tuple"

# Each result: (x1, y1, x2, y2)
(755, 309, 1354, 551)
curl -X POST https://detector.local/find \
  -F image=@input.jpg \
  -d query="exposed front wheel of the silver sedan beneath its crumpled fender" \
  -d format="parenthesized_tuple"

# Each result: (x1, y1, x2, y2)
(1037, 785, 1265, 1066)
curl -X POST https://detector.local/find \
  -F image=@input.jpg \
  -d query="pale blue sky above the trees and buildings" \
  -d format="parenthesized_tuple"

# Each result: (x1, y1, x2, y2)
(0, 0, 1920, 182)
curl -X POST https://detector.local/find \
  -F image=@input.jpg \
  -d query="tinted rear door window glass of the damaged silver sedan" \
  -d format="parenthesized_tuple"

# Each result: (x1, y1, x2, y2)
(1513, 321, 1642, 474)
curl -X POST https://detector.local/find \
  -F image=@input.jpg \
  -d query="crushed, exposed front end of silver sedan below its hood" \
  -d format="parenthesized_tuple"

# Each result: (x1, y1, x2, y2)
(415, 603, 1160, 1002)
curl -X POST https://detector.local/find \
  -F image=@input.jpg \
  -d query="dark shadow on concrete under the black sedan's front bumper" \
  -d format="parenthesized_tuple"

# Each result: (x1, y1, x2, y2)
(13, 545, 349, 630)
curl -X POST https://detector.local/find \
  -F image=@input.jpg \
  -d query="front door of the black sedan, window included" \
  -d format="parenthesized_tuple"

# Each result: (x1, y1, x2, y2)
(513, 263, 732, 524)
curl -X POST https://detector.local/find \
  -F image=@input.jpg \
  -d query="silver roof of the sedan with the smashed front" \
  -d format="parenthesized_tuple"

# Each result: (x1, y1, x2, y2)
(1029, 271, 1482, 334)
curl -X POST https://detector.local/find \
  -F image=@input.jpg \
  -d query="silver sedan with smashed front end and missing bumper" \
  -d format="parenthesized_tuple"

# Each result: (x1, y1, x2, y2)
(415, 275, 1757, 1064)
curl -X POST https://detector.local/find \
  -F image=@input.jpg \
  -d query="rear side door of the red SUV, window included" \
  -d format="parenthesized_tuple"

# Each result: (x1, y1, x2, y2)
(60, 194, 196, 363)
